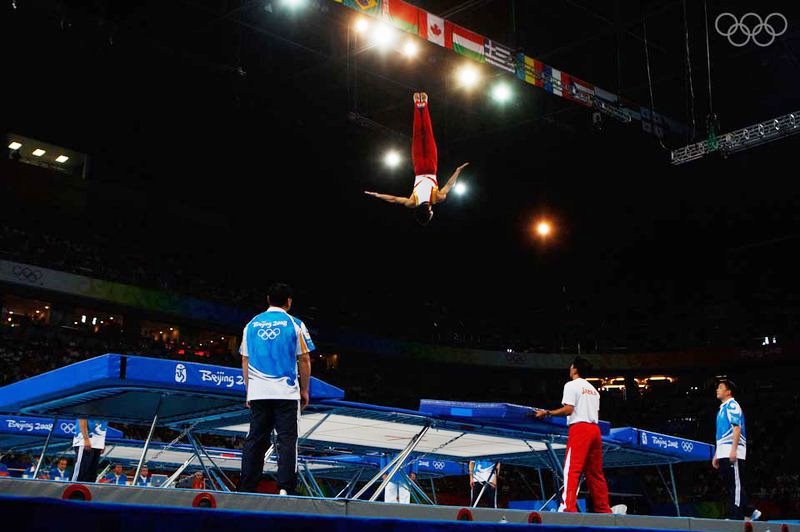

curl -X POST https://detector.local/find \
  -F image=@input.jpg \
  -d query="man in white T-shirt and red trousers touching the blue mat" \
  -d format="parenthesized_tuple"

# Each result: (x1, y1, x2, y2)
(536, 357, 611, 514)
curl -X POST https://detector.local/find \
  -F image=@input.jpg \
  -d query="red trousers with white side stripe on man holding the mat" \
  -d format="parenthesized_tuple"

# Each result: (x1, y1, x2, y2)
(561, 423, 611, 514)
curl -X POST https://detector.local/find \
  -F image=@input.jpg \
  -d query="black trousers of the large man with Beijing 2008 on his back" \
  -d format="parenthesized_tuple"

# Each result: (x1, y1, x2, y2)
(239, 399, 300, 494)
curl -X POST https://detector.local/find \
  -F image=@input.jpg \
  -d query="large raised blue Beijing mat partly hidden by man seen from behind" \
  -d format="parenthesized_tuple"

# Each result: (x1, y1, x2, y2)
(0, 354, 344, 424)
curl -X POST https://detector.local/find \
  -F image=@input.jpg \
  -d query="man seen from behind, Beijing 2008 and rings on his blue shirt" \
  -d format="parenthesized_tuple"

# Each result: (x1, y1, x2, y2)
(239, 283, 314, 495)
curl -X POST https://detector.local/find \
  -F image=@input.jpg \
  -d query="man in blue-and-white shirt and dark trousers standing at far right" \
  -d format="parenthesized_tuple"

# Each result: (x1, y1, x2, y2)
(711, 379, 761, 519)
